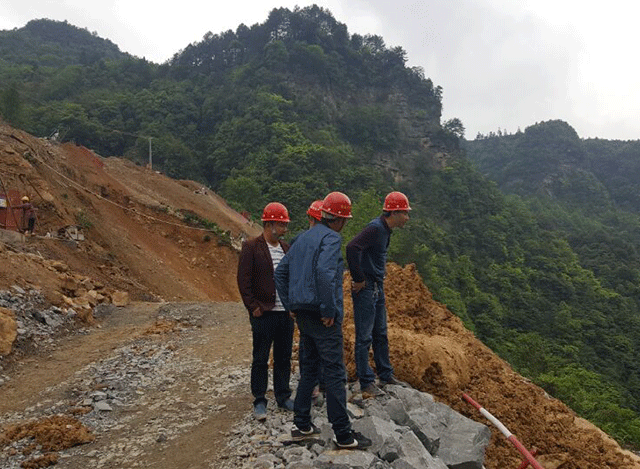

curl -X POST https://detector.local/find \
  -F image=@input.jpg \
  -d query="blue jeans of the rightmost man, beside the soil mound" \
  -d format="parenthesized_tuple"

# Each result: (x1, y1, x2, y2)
(351, 279, 393, 388)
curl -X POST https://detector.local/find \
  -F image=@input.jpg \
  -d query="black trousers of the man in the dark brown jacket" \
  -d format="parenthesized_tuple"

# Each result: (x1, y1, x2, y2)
(250, 311, 293, 405)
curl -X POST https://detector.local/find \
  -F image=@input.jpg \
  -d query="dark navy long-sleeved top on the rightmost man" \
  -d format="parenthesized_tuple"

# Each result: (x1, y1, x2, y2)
(347, 217, 391, 282)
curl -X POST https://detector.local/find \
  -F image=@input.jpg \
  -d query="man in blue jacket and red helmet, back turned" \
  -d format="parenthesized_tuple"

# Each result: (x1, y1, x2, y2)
(274, 192, 371, 449)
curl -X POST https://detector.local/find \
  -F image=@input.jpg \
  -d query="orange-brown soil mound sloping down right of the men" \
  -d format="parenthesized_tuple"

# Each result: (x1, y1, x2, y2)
(344, 264, 640, 469)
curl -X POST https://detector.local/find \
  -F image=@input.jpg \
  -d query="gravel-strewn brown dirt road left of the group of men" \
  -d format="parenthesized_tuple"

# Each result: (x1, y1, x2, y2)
(0, 303, 251, 469)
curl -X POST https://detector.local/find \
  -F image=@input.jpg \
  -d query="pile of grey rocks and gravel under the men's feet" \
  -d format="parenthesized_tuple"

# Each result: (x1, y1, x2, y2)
(220, 384, 491, 469)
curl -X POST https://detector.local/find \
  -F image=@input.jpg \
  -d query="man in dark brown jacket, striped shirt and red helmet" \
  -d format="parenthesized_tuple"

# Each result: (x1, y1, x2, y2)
(238, 202, 293, 421)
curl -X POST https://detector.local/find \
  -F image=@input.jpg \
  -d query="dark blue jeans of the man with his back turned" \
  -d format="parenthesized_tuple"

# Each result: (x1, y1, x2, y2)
(293, 310, 351, 439)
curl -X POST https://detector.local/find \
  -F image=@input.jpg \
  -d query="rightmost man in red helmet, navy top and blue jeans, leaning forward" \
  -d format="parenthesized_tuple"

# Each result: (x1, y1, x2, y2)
(347, 188, 411, 398)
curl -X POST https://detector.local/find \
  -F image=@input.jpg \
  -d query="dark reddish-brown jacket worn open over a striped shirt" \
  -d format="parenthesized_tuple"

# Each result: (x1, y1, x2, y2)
(238, 234, 289, 313)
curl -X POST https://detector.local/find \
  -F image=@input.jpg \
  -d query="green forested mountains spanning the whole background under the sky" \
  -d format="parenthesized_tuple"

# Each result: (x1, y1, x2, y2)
(0, 6, 640, 446)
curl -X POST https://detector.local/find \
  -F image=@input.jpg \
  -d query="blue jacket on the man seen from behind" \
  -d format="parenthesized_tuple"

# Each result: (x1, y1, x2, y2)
(274, 223, 344, 324)
